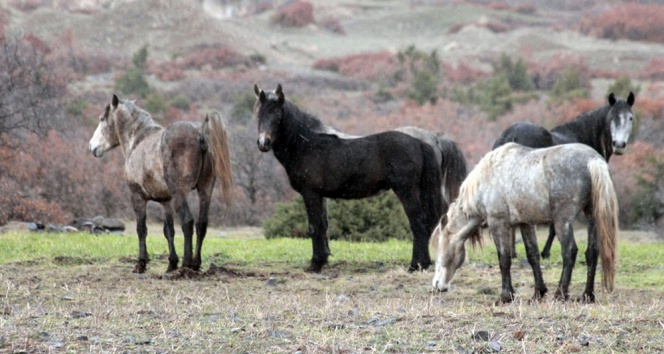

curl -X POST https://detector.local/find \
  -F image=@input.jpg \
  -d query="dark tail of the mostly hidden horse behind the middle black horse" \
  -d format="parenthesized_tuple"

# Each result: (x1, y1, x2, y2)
(436, 137, 468, 204)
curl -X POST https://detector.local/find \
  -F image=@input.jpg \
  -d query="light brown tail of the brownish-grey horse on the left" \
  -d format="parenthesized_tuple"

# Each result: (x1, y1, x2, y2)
(202, 112, 233, 206)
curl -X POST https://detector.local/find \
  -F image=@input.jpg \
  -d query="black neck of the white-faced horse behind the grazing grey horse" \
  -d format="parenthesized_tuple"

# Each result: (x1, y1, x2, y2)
(551, 105, 613, 161)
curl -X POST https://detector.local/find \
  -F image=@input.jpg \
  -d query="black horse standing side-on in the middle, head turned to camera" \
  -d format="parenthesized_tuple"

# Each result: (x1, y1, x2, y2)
(254, 85, 448, 272)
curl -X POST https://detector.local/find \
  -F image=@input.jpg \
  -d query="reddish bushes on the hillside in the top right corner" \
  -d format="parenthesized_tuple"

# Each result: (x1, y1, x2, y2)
(579, 3, 664, 43)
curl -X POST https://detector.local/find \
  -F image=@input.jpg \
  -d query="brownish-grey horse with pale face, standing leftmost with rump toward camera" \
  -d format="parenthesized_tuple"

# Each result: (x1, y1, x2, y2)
(90, 95, 233, 273)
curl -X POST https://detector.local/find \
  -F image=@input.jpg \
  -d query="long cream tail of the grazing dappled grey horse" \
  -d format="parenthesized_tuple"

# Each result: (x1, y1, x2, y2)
(588, 158, 618, 292)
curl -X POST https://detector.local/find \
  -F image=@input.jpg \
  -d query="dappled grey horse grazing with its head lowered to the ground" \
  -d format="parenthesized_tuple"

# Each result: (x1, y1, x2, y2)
(431, 143, 618, 303)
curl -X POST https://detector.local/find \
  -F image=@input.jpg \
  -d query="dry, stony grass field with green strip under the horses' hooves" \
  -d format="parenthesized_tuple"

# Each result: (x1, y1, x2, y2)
(0, 227, 664, 353)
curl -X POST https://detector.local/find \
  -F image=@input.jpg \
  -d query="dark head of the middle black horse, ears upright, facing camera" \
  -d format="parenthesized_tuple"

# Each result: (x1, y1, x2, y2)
(254, 84, 286, 152)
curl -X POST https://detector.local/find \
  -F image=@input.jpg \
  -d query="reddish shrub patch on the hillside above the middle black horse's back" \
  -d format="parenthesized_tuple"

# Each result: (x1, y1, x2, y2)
(313, 51, 397, 80)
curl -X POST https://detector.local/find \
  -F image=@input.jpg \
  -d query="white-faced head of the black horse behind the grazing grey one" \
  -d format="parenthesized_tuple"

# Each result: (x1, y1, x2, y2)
(607, 92, 634, 155)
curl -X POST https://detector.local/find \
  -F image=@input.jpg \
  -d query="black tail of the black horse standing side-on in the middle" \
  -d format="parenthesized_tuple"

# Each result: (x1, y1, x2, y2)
(420, 143, 448, 235)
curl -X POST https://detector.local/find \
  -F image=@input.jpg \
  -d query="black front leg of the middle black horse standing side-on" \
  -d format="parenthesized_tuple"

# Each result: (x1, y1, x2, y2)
(302, 192, 330, 273)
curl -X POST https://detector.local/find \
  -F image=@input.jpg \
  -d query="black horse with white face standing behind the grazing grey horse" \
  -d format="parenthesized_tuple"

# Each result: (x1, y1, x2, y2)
(493, 92, 634, 258)
